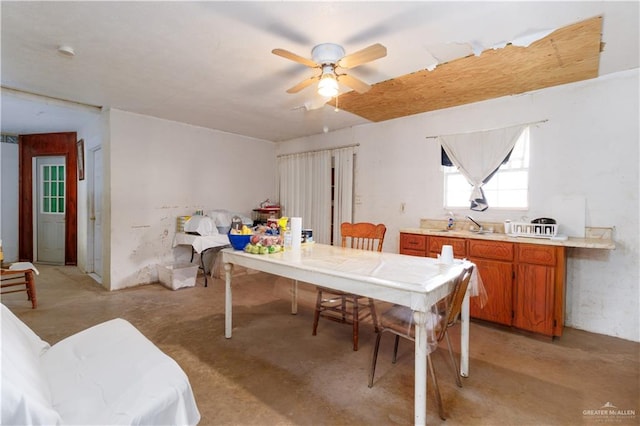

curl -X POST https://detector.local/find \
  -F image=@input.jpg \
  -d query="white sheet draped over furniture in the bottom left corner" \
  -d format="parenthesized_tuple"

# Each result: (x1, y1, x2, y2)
(2, 305, 200, 425)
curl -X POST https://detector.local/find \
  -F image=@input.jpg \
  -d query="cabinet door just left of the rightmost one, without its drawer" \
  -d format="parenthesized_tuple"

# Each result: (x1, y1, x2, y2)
(470, 258, 513, 325)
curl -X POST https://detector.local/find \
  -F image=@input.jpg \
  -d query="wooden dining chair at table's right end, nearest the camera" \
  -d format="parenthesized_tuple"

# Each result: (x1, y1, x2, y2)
(369, 265, 473, 420)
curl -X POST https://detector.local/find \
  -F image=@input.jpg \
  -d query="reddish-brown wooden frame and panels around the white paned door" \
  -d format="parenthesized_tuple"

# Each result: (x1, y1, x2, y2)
(18, 132, 78, 265)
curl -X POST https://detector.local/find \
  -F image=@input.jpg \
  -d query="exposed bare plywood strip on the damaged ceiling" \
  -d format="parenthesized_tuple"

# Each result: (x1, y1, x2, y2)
(329, 16, 602, 122)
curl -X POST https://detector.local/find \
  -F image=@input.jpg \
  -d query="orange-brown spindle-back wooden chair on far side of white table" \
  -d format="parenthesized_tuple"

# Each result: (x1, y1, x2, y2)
(313, 222, 387, 351)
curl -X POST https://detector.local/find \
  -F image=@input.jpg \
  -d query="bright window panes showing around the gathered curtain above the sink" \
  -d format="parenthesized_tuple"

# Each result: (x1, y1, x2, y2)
(443, 127, 529, 209)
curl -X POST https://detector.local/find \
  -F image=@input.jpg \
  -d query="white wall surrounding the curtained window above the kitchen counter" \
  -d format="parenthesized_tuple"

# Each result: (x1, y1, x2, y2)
(278, 69, 640, 341)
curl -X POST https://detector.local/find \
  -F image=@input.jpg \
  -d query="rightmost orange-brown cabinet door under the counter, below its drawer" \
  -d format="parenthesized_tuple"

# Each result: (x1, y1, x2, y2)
(513, 264, 555, 336)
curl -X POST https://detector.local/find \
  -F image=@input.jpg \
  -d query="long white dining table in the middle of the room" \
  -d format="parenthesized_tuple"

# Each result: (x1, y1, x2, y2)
(222, 244, 469, 425)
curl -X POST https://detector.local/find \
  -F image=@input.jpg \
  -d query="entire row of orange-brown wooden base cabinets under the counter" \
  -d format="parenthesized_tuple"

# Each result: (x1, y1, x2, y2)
(400, 233, 566, 336)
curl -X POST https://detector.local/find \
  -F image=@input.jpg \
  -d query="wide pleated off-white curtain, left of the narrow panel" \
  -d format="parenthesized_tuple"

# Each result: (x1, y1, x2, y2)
(278, 151, 331, 244)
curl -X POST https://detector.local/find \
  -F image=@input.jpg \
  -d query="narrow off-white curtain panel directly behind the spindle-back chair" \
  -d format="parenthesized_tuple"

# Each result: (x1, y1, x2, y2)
(333, 147, 355, 245)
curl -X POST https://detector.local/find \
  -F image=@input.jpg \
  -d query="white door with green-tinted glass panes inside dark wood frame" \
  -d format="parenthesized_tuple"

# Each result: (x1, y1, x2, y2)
(34, 156, 66, 265)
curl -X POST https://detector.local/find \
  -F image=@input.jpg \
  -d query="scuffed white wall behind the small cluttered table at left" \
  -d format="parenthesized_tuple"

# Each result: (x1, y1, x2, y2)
(103, 110, 276, 290)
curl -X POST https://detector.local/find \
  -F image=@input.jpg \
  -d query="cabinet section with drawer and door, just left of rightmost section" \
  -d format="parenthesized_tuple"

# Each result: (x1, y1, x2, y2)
(468, 240, 514, 325)
